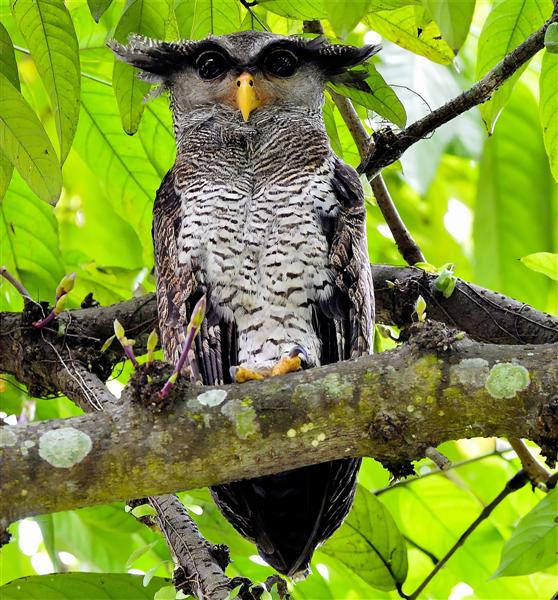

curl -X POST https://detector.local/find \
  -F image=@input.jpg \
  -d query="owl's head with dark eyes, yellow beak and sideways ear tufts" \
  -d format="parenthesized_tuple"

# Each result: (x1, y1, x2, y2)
(109, 31, 380, 121)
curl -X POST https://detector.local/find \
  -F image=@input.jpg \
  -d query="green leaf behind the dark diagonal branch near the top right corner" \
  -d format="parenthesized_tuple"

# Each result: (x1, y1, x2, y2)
(476, 0, 552, 133)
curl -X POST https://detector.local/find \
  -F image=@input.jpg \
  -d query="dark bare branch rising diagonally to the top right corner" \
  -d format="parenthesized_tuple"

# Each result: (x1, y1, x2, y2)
(359, 6, 558, 178)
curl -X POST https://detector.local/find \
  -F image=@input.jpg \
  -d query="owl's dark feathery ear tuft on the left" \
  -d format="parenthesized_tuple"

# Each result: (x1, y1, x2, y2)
(107, 34, 205, 84)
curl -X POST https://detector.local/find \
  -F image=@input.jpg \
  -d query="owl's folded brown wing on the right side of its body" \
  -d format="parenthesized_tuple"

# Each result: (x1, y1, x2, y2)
(314, 157, 374, 364)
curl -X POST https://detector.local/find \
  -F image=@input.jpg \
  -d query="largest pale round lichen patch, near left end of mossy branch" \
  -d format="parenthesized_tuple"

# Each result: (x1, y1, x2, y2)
(39, 427, 92, 469)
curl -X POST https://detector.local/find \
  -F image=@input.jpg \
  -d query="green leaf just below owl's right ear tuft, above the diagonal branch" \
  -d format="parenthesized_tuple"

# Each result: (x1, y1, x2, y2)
(332, 65, 407, 127)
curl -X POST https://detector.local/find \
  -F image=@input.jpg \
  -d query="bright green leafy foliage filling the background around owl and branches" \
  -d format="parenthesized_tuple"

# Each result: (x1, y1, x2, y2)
(0, 0, 558, 600)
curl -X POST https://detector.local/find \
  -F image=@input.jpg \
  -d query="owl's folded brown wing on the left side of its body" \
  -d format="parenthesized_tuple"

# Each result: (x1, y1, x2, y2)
(153, 170, 237, 385)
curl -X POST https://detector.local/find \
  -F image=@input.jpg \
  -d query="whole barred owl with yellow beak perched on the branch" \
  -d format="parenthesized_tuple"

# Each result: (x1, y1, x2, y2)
(111, 31, 378, 578)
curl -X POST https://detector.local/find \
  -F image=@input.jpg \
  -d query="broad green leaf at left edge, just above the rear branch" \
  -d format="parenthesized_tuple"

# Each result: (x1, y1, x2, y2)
(0, 169, 64, 306)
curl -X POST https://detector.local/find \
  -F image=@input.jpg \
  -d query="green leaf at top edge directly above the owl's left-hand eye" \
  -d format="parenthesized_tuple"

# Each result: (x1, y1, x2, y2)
(188, 0, 242, 40)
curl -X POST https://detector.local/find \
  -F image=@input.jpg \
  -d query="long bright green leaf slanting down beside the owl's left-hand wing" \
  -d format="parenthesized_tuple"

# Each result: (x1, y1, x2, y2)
(75, 79, 161, 265)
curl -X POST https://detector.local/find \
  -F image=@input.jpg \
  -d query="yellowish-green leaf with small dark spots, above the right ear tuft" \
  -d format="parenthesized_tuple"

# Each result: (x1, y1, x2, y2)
(366, 6, 454, 65)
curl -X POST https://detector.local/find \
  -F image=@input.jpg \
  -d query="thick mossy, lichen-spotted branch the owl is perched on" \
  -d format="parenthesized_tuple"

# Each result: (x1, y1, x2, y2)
(0, 338, 558, 521)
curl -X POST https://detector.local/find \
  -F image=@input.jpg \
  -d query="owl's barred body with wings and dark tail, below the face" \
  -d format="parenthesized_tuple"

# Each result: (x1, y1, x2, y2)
(153, 110, 373, 574)
